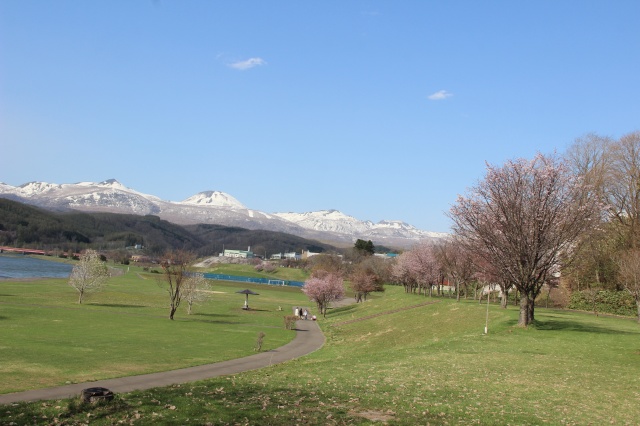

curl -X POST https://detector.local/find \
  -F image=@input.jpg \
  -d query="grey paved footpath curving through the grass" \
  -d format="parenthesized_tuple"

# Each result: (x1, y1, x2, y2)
(0, 320, 324, 404)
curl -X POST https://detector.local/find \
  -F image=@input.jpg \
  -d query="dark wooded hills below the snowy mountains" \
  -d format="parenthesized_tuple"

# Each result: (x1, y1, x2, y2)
(0, 198, 336, 256)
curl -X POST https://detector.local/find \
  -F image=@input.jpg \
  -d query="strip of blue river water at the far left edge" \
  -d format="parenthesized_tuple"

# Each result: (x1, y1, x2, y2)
(0, 254, 73, 279)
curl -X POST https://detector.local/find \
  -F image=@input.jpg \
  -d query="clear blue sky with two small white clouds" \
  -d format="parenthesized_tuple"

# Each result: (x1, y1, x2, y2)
(0, 0, 640, 232)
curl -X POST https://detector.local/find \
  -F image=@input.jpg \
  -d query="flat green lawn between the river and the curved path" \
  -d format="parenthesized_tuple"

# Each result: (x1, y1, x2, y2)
(0, 267, 306, 393)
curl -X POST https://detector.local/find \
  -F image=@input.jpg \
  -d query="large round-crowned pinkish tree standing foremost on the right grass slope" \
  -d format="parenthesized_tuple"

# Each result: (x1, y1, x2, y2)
(449, 154, 598, 326)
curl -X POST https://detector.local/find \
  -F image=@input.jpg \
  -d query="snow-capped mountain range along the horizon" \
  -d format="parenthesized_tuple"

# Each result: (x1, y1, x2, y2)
(0, 179, 447, 248)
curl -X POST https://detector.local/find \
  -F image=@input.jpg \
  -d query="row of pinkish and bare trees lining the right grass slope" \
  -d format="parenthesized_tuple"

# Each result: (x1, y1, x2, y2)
(393, 132, 640, 326)
